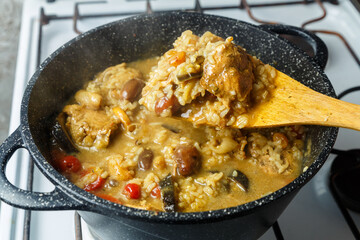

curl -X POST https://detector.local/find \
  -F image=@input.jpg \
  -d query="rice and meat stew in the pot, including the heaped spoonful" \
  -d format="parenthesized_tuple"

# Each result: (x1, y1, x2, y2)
(52, 31, 306, 212)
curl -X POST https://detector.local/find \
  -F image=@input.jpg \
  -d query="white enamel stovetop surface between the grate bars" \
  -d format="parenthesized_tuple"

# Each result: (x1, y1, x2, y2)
(0, 0, 360, 240)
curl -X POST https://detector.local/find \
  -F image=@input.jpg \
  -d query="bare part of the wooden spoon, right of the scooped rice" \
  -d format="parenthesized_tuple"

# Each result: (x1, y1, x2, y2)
(246, 71, 360, 131)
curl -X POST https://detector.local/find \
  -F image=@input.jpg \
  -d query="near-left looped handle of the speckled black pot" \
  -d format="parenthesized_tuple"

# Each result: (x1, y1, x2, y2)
(0, 127, 84, 210)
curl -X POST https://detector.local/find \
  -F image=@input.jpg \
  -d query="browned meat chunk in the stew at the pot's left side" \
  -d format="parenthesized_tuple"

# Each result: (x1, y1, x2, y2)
(63, 105, 118, 149)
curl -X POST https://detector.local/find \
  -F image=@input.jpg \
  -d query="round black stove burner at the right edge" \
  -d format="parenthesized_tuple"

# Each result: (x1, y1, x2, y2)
(331, 149, 360, 212)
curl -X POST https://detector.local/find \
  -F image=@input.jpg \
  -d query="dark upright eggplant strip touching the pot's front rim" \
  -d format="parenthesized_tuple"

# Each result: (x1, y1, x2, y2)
(159, 174, 176, 212)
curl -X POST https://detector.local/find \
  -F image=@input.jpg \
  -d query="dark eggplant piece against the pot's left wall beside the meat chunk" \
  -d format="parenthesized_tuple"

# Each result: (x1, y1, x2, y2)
(51, 112, 78, 153)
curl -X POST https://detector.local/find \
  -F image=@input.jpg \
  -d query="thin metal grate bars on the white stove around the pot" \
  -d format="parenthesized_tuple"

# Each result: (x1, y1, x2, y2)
(23, 0, 360, 240)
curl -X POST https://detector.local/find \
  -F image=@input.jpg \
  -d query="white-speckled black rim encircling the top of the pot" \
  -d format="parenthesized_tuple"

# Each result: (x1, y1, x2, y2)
(21, 12, 338, 223)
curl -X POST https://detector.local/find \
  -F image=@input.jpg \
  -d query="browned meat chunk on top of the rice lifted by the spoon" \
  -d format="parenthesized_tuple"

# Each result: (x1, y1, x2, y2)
(200, 38, 254, 102)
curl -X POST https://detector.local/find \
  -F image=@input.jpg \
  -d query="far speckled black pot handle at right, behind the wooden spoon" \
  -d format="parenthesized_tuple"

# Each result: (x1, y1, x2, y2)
(259, 24, 328, 69)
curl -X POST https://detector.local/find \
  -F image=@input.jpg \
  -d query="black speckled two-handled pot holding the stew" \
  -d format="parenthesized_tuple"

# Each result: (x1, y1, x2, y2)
(0, 12, 337, 239)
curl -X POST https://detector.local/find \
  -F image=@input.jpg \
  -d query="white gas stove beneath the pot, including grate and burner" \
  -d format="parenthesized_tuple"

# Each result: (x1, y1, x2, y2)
(0, 0, 360, 240)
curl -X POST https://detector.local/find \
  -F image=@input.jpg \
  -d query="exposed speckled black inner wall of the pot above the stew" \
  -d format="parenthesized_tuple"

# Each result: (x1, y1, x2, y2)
(22, 12, 336, 216)
